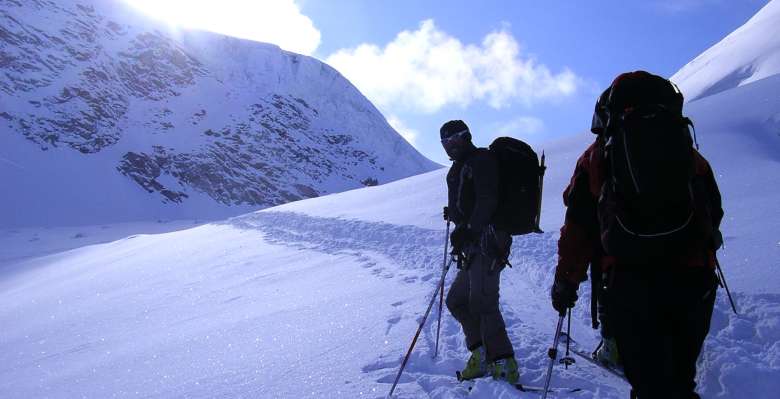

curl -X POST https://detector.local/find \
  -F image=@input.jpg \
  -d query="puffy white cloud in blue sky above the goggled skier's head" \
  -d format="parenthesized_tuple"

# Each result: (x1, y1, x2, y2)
(327, 20, 579, 113)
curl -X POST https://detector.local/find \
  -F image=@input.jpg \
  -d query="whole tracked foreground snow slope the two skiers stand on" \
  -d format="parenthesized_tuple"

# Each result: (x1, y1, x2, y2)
(0, 73, 780, 398)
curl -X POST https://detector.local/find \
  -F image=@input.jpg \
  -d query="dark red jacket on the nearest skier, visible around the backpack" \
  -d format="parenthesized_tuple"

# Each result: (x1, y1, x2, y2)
(555, 139, 723, 286)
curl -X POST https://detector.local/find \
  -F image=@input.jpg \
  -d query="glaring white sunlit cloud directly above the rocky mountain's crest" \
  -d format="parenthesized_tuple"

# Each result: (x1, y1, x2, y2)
(125, 0, 320, 55)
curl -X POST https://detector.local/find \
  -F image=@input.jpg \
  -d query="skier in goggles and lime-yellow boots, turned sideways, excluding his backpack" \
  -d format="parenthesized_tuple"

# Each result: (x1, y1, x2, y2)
(440, 120, 519, 384)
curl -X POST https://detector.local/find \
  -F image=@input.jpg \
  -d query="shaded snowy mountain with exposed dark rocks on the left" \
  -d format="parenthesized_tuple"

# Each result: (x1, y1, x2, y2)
(0, 0, 437, 226)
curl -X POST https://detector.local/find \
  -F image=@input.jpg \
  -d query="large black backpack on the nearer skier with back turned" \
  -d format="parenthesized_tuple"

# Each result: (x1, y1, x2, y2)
(598, 71, 711, 262)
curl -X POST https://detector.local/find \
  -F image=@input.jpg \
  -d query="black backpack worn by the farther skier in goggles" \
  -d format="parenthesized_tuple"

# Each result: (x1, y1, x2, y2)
(489, 137, 545, 235)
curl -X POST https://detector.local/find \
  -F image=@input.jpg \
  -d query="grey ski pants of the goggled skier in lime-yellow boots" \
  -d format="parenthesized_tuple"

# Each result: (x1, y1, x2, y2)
(447, 252, 514, 361)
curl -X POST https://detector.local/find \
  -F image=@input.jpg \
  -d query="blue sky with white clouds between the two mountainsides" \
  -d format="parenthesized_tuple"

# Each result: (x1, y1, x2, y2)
(126, 0, 766, 163)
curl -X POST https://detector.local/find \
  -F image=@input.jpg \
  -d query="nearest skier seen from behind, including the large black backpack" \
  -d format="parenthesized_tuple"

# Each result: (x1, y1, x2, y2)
(551, 71, 723, 399)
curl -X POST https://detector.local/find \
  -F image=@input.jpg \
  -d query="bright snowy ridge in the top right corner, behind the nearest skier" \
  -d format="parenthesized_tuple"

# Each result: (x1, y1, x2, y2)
(671, 0, 780, 101)
